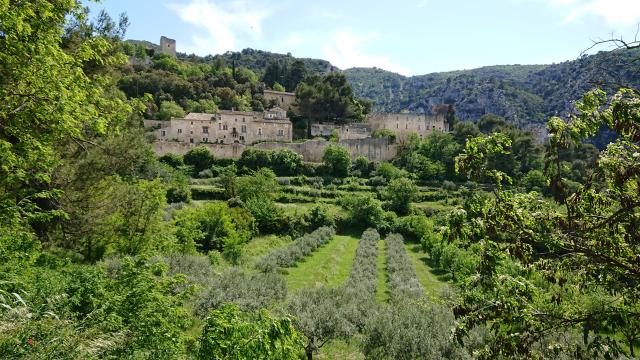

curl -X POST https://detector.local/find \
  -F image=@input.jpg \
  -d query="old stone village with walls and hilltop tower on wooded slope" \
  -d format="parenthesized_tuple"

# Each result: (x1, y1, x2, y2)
(144, 37, 449, 162)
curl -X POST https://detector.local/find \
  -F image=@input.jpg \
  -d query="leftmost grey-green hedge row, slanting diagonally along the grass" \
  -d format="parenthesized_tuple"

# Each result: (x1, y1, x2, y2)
(256, 226, 336, 272)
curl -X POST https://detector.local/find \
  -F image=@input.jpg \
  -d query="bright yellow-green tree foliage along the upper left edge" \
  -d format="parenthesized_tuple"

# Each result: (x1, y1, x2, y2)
(0, 0, 137, 248)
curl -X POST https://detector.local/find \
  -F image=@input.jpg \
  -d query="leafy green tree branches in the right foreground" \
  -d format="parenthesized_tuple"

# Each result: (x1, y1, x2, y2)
(450, 89, 640, 358)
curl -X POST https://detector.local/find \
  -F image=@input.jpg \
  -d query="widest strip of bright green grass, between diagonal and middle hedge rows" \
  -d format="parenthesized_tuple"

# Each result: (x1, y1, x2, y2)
(286, 235, 358, 292)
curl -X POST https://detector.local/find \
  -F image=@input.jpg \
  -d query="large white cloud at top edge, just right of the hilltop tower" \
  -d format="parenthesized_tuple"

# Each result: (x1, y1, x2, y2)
(169, 0, 272, 54)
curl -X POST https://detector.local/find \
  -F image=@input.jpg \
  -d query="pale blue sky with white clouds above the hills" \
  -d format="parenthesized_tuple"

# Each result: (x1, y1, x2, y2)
(92, 0, 640, 75)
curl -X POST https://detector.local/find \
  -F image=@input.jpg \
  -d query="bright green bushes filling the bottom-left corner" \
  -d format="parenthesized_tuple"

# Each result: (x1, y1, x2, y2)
(0, 258, 190, 359)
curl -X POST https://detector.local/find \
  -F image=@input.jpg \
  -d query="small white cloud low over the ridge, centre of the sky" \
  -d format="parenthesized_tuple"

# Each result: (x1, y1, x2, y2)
(322, 31, 408, 74)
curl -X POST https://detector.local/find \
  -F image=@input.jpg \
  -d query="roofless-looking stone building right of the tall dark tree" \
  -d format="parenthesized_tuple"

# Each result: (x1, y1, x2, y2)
(366, 113, 449, 142)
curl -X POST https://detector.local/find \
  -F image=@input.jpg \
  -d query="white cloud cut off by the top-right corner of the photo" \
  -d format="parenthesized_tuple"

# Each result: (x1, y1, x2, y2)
(547, 0, 640, 27)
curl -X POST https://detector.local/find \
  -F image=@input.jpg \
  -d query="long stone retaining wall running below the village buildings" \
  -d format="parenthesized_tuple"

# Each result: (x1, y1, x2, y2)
(153, 138, 398, 162)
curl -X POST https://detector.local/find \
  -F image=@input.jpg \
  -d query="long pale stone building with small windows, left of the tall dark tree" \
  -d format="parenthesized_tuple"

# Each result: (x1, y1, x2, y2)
(145, 107, 292, 144)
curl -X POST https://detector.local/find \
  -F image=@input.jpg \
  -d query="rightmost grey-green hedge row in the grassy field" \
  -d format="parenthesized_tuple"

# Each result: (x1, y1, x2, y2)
(385, 234, 424, 301)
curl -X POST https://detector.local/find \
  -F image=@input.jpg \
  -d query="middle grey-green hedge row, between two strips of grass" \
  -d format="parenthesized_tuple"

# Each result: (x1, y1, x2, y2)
(345, 229, 380, 296)
